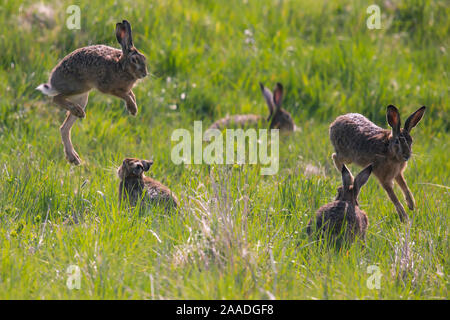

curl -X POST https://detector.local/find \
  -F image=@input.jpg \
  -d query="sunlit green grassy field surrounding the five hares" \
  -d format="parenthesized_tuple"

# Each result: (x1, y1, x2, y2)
(0, 0, 450, 299)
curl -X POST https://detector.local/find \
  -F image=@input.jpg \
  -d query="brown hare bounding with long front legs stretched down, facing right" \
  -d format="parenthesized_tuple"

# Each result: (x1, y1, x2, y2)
(330, 105, 426, 221)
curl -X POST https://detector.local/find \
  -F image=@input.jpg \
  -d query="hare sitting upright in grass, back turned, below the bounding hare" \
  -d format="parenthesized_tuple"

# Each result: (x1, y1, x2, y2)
(306, 165, 372, 247)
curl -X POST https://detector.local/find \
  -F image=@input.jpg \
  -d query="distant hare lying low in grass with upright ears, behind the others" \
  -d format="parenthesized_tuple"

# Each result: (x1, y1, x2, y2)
(209, 83, 295, 132)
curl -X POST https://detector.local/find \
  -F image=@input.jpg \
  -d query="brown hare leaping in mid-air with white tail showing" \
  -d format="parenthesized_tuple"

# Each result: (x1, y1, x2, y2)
(36, 20, 147, 165)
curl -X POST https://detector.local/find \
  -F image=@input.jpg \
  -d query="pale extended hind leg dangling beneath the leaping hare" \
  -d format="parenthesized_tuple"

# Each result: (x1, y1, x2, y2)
(59, 93, 89, 165)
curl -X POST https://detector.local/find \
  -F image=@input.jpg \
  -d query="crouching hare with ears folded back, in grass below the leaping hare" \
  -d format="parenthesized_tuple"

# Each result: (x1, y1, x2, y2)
(117, 158, 179, 208)
